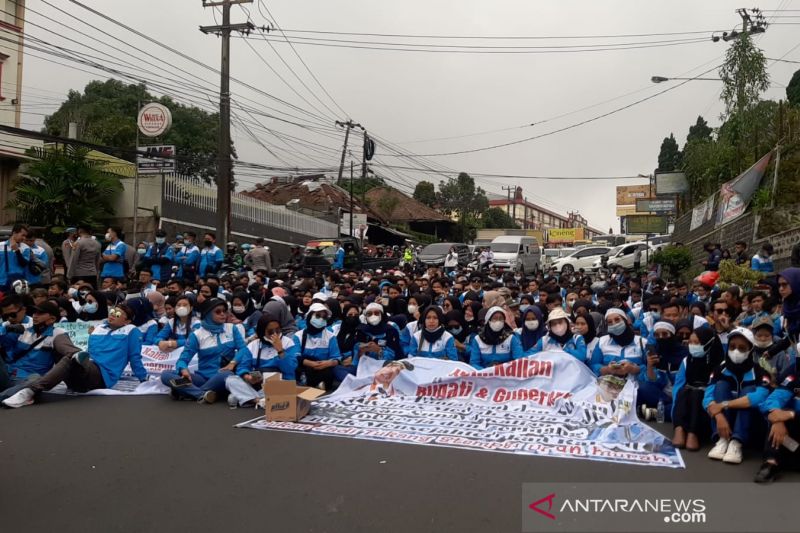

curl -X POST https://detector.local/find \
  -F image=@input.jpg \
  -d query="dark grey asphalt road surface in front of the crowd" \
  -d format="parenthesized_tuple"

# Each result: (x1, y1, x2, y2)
(0, 395, 800, 533)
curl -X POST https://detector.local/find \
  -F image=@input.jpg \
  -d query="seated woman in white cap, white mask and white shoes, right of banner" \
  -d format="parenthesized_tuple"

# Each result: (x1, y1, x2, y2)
(703, 328, 769, 464)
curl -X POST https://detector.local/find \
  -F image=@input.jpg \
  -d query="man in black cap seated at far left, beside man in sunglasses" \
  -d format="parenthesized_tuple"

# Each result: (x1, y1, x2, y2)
(0, 301, 80, 400)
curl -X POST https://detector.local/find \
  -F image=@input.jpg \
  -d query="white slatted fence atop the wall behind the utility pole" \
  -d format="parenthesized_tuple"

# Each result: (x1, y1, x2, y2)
(164, 175, 338, 237)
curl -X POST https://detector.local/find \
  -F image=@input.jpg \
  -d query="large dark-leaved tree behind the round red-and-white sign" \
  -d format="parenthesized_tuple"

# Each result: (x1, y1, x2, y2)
(44, 80, 223, 181)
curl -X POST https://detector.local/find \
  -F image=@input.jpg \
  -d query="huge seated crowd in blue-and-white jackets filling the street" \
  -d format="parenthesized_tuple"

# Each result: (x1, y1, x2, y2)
(0, 220, 800, 482)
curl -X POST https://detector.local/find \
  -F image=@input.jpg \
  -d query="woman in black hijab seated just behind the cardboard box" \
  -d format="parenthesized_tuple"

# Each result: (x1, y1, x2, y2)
(225, 315, 300, 407)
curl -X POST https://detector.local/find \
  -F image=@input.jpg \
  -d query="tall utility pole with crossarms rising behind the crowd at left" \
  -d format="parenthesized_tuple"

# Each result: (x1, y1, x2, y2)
(200, 0, 255, 243)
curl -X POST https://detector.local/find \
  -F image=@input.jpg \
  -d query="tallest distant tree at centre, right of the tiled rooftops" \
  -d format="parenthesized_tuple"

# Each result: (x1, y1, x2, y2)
(436, 172, 489, 242)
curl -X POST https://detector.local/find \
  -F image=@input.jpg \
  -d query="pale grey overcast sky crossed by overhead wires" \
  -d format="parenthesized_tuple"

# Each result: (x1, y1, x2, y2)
(18, 0, 800, 231)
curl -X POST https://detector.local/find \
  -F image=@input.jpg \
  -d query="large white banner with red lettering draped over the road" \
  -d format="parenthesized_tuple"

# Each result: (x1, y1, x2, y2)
(237, 351, 683, 468)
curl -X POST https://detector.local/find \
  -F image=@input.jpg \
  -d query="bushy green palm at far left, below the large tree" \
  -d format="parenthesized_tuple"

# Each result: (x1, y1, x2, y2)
(8, 146, 122, 228)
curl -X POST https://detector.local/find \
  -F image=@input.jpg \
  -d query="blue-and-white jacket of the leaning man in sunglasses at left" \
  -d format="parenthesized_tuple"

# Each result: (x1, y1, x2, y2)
(87, 322, 147, 389)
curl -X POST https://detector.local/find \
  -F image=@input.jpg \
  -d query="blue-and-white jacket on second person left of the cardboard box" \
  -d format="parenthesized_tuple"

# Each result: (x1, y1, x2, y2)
(175, 324, 246, 379)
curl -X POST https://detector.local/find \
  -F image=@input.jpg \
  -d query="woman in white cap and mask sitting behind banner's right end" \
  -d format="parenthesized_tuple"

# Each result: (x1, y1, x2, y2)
(591, 307, 646, 379)
